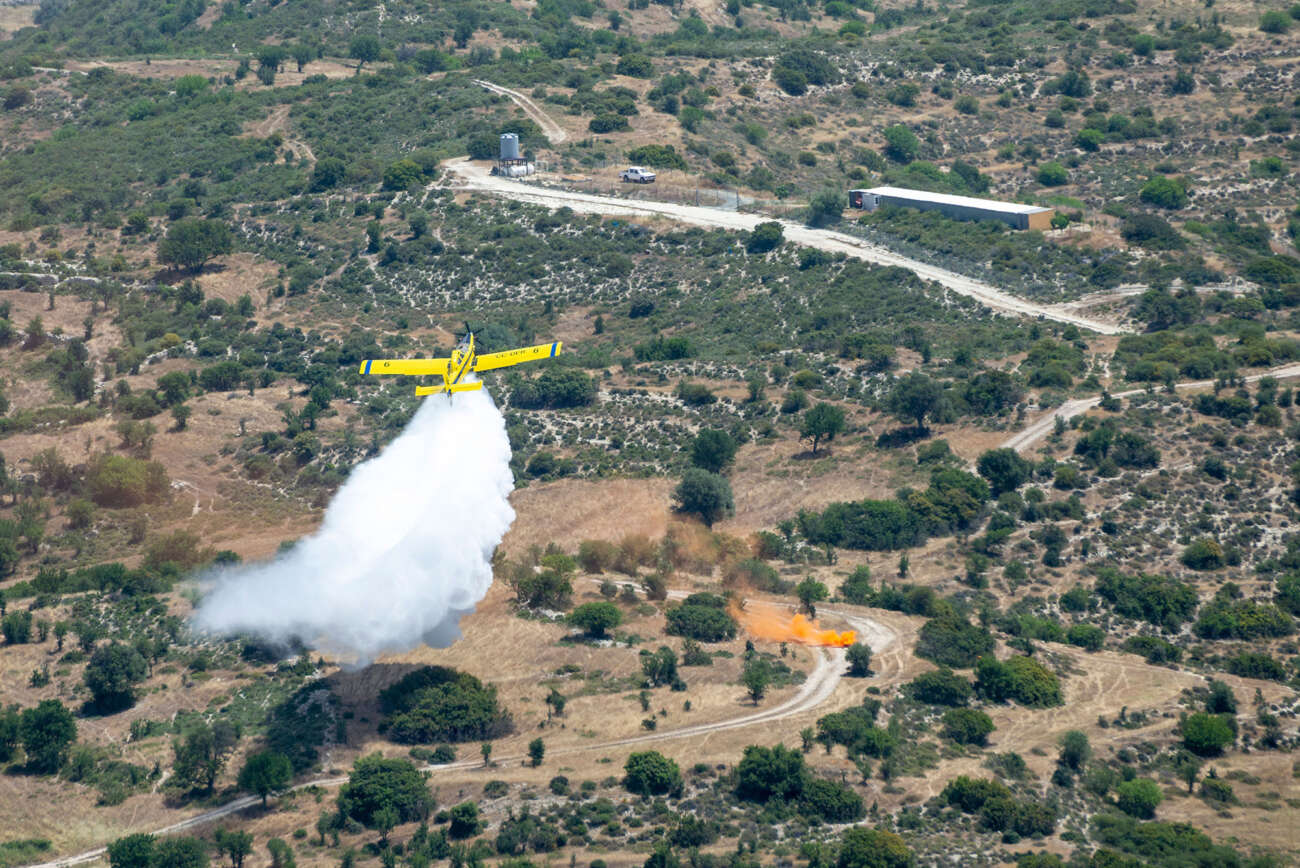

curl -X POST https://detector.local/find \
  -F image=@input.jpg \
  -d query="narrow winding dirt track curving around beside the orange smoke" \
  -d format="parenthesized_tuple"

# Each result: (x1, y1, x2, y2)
(29, 602, 898, 868)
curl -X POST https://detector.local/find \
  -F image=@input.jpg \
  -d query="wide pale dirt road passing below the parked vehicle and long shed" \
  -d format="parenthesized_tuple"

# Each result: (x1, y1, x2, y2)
(446, 159, 1130, 334)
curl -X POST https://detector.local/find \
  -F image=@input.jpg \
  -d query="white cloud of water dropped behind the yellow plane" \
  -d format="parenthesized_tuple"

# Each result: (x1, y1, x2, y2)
(194, 390, 515, 664)
